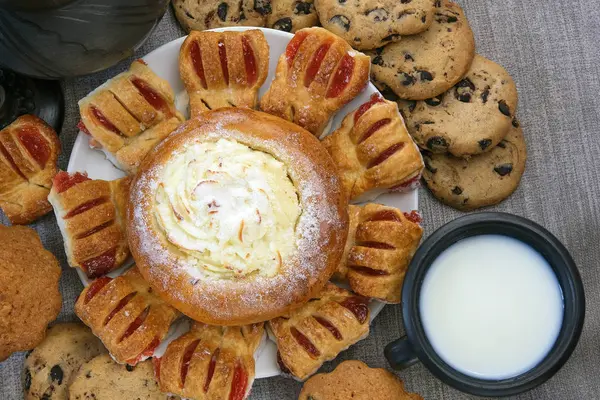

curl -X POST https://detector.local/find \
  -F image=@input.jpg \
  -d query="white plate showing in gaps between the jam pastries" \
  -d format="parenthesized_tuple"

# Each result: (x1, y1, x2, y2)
(67, 27, 418, 378)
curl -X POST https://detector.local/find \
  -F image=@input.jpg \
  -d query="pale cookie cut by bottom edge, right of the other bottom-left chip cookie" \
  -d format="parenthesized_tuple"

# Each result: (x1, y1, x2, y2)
(68, 354, 164, 400)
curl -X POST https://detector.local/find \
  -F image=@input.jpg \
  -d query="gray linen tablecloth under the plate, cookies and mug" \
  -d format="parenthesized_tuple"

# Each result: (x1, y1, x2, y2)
(0, 0, 600, 400)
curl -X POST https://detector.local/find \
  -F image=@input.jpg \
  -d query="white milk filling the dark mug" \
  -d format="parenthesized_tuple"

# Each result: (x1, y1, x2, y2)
(419, 235, 564, 380)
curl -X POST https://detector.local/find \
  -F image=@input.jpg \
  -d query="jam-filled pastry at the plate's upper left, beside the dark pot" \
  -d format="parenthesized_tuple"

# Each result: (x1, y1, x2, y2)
(79, 60, 183, 173)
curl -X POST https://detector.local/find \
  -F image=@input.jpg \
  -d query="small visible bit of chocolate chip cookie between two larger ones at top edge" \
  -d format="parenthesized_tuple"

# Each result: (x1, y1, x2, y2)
(267, 0, 319, 32)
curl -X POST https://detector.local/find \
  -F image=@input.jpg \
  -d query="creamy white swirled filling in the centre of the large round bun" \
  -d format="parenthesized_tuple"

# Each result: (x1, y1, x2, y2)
(154, 139, 301, 278)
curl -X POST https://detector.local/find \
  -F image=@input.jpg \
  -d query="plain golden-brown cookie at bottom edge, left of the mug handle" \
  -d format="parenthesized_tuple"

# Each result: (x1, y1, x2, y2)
(298, 360, 423, 400)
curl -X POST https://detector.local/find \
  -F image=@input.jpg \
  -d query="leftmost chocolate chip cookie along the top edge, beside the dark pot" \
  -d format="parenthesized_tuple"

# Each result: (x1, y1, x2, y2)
(173, 0, 271, 32)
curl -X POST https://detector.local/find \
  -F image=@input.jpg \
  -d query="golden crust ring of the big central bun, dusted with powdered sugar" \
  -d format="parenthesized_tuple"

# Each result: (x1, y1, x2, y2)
(128, 108, 348, 325)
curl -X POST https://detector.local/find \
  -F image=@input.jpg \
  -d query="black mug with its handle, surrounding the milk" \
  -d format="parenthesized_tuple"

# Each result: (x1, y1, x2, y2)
(385, 212, 585, 397)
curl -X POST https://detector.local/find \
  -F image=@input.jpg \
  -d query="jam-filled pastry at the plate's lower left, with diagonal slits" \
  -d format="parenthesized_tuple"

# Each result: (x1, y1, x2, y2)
(75, 266, 180, 365)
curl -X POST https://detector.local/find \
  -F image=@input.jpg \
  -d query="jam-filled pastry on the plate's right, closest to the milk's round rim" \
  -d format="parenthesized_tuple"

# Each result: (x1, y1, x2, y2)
(334, 203, 423, 303)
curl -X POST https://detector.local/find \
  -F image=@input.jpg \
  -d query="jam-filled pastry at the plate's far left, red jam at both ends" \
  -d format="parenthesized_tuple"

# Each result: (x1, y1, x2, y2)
(48, 171, 130, 278)
